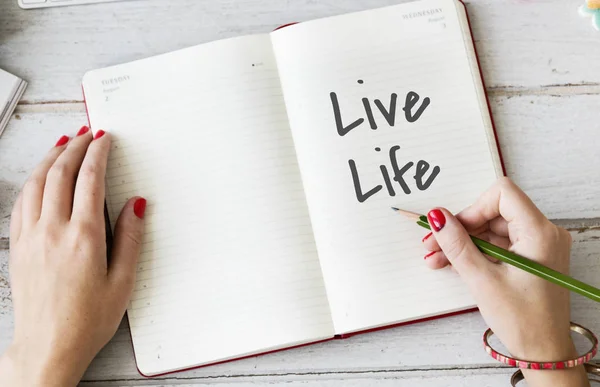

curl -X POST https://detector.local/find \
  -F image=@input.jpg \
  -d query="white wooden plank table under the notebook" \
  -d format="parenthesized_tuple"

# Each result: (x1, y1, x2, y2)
(0, 0, 600, 387)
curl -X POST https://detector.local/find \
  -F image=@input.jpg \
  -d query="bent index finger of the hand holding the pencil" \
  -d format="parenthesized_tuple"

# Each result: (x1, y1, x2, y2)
(457, 177, 547, 229)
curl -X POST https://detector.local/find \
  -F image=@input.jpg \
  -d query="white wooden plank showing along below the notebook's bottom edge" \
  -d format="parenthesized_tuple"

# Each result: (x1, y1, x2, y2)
(0, 230, 600, 386)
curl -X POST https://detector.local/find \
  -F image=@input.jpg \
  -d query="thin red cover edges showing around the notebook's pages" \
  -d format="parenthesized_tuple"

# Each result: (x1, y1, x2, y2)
(83, 0, 506, 378)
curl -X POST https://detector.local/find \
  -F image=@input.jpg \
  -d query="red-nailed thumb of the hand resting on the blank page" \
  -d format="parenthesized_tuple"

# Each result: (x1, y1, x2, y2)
(108, 197, 146, 299)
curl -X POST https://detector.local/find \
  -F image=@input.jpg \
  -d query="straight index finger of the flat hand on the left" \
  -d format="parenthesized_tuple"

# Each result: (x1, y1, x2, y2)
(71, 130, 110, 222)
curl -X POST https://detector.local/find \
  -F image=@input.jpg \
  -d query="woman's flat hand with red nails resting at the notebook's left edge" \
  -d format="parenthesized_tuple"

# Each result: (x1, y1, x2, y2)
(0, 127, 146, 387)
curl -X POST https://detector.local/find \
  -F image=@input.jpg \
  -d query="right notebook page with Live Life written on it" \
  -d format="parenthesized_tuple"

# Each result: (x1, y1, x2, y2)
(272, 0, 502, 334)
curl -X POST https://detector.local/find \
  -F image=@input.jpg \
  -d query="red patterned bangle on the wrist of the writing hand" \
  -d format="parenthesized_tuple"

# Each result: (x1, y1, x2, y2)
(483, 323, 598, 370)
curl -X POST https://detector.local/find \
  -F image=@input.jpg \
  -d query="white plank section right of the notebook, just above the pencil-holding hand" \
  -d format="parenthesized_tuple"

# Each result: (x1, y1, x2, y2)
(491, 95, 600, 219)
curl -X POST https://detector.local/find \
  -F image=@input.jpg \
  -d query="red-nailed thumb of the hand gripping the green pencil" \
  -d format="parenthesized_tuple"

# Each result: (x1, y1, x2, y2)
(427, 208, 496, 284)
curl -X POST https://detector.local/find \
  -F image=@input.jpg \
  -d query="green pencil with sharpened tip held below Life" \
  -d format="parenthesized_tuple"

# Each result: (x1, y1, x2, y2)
(392, 207, 600, 302)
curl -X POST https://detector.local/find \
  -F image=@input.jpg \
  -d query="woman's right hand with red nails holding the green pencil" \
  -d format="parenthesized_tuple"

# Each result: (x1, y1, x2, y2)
(423, 178, 589, 387)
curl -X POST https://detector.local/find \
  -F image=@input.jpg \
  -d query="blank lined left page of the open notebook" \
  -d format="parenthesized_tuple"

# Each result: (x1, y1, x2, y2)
(84, 35, 333, 375)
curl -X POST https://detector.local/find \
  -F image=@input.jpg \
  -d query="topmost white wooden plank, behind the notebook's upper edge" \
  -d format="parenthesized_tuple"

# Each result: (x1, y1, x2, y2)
(0, 0, 600, 103)
